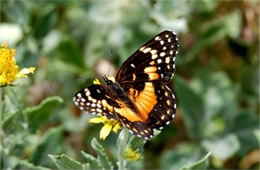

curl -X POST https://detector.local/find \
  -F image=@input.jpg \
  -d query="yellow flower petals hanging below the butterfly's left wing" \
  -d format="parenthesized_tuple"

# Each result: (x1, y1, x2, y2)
(89, 116, 121, 140)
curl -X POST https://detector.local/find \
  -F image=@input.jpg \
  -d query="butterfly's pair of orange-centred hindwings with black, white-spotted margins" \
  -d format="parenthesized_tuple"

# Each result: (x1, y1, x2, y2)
(118, 82, 176, 139)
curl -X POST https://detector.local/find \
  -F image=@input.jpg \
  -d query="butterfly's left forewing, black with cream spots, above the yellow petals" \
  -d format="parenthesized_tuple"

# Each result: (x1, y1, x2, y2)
(73, 84, 118, 120)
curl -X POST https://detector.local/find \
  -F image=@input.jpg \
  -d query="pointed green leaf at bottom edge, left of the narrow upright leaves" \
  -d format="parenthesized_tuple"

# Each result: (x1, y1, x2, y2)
(48, 154, 83, 170)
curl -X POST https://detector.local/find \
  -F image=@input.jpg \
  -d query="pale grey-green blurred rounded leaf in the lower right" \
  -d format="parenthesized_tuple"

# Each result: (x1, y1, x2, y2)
(202, 134, 240, 160)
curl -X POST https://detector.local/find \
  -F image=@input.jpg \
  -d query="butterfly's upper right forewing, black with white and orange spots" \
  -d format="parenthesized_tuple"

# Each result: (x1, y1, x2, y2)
(116, 31, 179, 84)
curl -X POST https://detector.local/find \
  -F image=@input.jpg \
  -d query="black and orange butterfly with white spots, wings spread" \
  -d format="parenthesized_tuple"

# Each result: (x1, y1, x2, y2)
(73, 30, 179, 140)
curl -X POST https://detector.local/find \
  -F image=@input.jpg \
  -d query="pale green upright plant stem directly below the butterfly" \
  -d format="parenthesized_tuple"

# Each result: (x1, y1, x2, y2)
(117, 128, 129, 170)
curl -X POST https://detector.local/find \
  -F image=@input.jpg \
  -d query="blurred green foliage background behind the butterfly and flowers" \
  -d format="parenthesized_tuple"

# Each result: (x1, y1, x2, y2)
(0, 0, 260, 169)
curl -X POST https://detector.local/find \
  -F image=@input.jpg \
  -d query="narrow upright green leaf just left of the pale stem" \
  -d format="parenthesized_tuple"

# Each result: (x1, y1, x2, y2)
(91, 138, 113, 169)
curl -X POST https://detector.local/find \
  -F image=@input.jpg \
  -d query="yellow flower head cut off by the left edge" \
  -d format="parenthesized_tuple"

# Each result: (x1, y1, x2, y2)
(0, 43, 35, 86)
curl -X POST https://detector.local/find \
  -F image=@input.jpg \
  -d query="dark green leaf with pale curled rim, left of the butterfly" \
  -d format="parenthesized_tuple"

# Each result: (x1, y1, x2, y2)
(25, 96, 63, 132)
